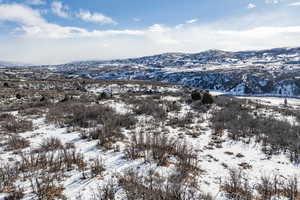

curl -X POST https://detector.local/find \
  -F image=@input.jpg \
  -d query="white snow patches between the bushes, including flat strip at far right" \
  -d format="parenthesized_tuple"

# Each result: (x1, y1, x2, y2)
(0, 77, 300, 200)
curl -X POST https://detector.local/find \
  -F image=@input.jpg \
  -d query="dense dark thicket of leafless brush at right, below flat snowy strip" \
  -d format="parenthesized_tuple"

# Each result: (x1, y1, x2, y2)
(211, 97, 300, 163)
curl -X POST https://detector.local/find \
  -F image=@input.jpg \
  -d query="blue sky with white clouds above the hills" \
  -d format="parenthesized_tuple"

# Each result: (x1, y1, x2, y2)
(0, 0, 300, 64)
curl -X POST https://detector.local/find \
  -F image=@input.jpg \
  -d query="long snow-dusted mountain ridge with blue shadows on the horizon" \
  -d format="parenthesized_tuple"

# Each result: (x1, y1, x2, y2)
(40, 47, 300, 96)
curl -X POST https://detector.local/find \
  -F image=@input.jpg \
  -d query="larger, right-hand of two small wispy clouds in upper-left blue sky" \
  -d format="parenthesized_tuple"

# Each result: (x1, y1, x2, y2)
(77, 10, 117, 24)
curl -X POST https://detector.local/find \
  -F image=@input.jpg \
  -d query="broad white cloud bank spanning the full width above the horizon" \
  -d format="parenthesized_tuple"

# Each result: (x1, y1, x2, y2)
(0, 4, 300, 64)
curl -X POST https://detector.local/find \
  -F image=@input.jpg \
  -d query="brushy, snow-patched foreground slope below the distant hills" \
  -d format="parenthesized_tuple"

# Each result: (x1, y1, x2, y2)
(0, 75, 300, 200)
